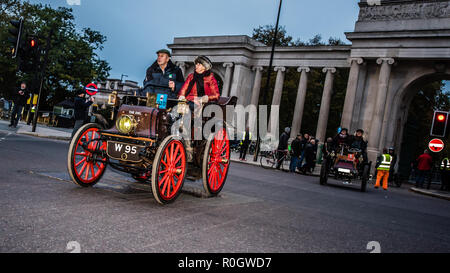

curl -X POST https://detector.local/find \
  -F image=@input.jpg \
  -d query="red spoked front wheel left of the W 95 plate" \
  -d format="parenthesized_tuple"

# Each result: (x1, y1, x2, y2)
(67, 123, 106, 187)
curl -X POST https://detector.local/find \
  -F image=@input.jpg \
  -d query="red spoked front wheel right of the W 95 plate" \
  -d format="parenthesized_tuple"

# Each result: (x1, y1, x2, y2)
(152, 136, 187, 204)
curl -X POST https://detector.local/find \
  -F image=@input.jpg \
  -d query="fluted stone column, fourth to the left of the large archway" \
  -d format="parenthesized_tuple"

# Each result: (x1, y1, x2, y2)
(291, 67, 311, 138)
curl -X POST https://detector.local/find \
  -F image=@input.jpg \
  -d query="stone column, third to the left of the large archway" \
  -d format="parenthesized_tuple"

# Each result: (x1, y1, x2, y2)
(316, 67, 336, 143)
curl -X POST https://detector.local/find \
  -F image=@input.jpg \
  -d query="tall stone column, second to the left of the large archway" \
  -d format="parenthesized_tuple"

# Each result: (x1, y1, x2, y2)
(341, 58, 364, 130)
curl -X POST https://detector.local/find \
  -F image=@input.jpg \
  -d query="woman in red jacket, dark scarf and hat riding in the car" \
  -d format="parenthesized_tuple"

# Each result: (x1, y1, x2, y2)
(178, 56, 220, 110)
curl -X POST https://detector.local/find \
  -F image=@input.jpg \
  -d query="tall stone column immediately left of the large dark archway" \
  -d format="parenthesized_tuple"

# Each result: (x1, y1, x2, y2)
(367, 58, 394, 153)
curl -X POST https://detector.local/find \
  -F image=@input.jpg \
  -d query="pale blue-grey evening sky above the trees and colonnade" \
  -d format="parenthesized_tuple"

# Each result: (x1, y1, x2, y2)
(29, 0, 358, 85)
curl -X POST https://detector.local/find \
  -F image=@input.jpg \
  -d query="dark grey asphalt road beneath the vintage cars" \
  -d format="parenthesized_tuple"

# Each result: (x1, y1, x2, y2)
(0, 124, 450, 253)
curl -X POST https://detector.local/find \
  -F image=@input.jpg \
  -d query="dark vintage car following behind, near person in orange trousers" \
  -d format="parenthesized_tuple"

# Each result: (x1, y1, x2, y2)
(320, 145, 372, 192)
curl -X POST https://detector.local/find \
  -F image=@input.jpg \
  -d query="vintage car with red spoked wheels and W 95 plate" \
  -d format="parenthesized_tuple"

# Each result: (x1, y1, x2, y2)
(67, 87, 237, 204)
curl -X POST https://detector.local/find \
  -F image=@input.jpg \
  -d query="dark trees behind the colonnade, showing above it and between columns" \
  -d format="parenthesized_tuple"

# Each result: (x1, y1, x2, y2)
(252, 25, 349, 141)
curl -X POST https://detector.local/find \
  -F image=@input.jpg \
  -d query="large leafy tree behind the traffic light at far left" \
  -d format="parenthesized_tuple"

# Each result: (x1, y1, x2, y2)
(0, 0, 111, 109)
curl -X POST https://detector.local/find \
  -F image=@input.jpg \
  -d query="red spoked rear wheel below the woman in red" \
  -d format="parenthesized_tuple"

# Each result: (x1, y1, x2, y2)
(202, 128, 230, 196)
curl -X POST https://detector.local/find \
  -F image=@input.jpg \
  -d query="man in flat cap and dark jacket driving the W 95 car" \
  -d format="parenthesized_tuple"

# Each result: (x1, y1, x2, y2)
(142, 49, 184, 99)
